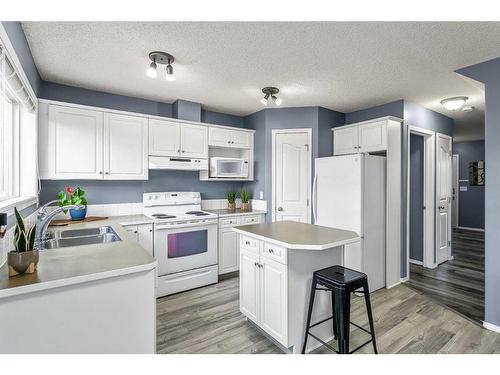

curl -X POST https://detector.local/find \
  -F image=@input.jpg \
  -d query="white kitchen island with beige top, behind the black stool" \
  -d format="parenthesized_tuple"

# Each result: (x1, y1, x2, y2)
(233, 221, 361, 353)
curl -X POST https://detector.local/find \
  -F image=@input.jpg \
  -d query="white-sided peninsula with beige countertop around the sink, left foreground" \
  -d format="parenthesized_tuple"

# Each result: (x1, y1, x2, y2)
(0, 215, 156, 354)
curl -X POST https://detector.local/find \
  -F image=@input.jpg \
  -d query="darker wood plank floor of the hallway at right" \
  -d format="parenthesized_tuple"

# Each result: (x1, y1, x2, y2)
(408, 229, 484, 324)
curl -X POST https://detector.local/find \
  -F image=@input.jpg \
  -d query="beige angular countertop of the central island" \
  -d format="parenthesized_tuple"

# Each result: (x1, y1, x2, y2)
(233, 221, 361, 250)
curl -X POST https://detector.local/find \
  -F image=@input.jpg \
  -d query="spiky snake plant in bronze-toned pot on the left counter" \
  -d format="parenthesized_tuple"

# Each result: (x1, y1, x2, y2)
(7, 208, 38, 277)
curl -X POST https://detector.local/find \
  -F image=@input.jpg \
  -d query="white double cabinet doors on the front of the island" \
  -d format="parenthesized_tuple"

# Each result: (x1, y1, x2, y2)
(240, 239, 288, 347)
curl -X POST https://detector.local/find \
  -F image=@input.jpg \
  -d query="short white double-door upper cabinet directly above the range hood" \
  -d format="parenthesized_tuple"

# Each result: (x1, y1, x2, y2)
(149, 119, 208, 158)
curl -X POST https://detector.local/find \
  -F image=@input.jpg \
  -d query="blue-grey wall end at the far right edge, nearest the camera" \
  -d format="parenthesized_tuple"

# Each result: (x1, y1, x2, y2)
(457, 58, 500, 327)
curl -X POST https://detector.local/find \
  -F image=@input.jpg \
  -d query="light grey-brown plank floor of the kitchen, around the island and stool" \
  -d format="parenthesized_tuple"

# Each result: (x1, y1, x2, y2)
(157, 270, 500, 354)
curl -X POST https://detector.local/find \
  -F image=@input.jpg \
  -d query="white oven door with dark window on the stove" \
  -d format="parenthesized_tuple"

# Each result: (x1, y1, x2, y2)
(154, 222, 217, 276)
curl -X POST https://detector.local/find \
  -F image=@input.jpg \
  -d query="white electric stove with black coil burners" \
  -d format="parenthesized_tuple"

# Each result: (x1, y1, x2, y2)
(142, 192, 218, 297)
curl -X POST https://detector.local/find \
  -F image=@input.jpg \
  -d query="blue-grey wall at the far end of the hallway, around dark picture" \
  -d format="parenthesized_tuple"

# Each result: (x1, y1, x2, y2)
(453, 141, 487, 229)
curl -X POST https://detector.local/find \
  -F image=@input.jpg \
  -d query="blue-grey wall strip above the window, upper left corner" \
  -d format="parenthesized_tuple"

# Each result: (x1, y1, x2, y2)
(2, 21, 41, 95)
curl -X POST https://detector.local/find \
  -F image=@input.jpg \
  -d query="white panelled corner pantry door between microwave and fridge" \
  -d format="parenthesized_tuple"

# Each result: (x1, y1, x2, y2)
(273, 130, 311, 223)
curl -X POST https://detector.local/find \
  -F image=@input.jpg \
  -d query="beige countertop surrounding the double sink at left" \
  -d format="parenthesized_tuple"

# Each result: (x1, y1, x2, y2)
(0, 215, 156, 299)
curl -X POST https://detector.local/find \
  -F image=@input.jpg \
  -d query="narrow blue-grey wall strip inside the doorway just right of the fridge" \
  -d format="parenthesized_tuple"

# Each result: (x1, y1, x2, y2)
(410, 134, 424, 261)
